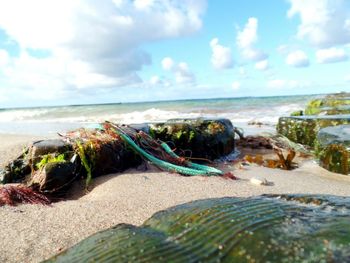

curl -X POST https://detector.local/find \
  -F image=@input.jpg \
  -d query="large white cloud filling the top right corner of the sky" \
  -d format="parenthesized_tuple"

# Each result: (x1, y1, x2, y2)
(288, 0, 350, 47)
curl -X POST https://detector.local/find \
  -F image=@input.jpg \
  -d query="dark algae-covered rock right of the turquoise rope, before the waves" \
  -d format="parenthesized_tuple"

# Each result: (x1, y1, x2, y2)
(150, 118, 234, 159)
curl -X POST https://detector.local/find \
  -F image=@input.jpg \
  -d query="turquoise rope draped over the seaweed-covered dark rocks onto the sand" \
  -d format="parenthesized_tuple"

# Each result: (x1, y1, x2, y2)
(108, 123, 223, 176)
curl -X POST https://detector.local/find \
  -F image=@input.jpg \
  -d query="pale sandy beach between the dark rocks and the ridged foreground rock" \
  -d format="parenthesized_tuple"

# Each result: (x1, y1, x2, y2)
(0, 134, 350, 262)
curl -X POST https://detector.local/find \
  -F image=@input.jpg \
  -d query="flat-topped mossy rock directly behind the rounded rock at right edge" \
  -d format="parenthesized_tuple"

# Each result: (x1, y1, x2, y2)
(277, 115, 350, 147)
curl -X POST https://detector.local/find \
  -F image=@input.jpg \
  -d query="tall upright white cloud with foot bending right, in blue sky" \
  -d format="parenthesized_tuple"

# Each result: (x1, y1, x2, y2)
(236, 17, 268, 61)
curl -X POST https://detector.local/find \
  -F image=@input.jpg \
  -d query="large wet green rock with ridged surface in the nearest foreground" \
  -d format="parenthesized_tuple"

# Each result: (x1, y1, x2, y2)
(46, 195, 350, 262)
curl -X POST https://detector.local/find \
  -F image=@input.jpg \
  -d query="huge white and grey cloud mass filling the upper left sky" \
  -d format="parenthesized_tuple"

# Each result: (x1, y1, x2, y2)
(0, 0, 206, 105)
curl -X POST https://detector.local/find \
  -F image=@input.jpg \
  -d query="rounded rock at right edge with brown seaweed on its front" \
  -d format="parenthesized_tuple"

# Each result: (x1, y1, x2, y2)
(316, 125, 350, 175)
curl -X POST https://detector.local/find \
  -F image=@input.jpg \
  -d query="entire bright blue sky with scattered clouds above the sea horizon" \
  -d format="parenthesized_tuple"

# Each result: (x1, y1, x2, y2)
(0, 0, 350, 108)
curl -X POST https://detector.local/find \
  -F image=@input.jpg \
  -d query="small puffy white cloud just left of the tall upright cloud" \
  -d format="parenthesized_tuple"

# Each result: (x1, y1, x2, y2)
(210, 38, 233, 69)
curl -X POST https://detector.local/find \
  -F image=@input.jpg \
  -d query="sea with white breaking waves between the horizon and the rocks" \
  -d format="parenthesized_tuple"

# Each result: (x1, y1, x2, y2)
(0, 95, 318, 135)
